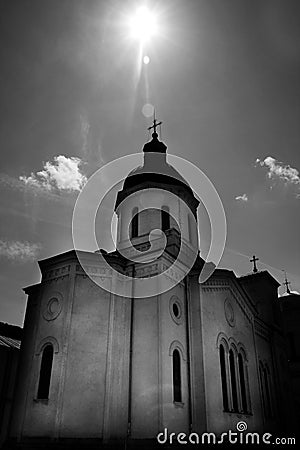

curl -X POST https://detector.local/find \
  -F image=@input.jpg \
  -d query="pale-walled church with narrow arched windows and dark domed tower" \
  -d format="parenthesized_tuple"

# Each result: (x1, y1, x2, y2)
(8, 127, 294, 448)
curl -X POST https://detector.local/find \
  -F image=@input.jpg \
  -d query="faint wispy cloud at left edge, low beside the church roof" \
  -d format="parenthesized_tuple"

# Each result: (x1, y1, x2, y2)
(0, 239, 41, 262)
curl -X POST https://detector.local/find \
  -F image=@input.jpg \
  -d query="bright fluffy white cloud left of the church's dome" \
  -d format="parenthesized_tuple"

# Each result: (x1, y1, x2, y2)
(19, 155, 87, 192)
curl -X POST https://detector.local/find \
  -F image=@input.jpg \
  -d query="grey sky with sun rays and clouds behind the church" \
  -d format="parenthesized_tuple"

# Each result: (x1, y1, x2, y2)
(0, 0, 300, 325)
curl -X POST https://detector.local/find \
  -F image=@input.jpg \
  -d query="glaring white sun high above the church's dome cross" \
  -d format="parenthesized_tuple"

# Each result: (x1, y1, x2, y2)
(129, 6, 157, 42)
